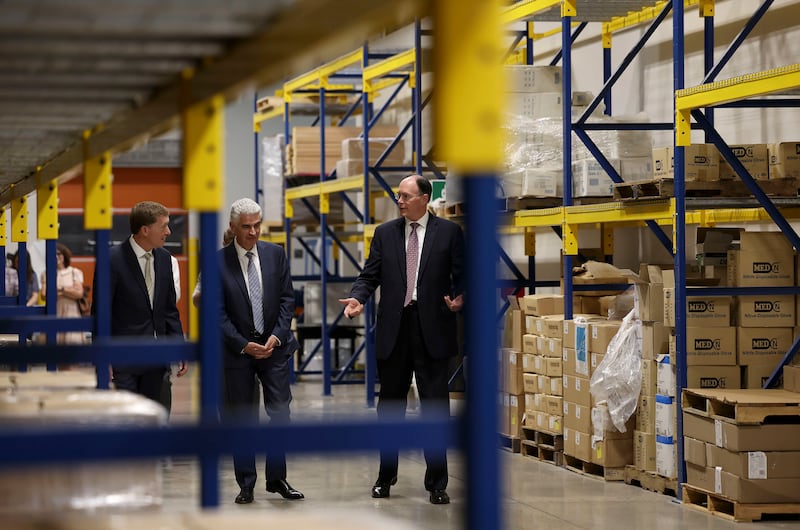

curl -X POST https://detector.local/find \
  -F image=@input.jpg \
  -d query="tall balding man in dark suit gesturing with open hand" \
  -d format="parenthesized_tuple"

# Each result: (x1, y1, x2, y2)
(339, 175, 464, 504)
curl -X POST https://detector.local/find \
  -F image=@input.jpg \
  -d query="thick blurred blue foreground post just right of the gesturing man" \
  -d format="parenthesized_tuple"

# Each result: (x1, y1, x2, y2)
(464, 175, 503, 530)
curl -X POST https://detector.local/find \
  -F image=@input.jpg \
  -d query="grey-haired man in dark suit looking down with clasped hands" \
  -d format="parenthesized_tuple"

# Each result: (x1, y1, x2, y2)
(219, 199, 304, 504)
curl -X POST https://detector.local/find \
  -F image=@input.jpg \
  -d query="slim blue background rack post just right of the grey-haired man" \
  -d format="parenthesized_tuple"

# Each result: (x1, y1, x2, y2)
(319, 87, 332, 396)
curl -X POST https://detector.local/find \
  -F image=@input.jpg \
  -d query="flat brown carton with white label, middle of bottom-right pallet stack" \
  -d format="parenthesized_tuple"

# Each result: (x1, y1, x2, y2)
(705, 443, 800, 480)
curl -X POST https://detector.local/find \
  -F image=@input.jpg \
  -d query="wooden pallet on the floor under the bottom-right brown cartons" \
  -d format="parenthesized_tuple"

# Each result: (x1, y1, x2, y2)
(681, 484, 800, 522)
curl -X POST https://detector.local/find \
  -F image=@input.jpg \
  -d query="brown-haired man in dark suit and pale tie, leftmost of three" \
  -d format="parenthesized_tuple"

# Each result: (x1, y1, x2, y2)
(108, 201, 188, 402)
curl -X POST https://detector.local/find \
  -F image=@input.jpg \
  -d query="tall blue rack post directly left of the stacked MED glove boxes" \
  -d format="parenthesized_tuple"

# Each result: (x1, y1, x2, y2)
(672, 1, 686, 497)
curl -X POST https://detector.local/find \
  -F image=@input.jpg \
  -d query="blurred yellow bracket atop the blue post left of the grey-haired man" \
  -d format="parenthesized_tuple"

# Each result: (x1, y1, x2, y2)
(182, 94, 225, 212)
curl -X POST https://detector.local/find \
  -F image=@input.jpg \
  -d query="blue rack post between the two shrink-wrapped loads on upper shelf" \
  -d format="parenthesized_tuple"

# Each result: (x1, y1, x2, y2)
(561, 16, 572, 320)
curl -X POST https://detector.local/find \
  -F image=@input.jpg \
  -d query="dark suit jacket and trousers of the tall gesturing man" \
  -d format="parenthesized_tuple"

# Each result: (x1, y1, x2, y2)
(350, 214, 464, 491)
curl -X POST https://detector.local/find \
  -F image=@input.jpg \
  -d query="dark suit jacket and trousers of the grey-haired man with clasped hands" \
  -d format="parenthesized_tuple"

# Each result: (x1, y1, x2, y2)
(219, 241, 297, 489)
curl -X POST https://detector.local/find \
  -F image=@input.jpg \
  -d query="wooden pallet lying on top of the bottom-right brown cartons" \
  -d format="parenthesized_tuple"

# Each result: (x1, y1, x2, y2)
(683, 388, 800, 425)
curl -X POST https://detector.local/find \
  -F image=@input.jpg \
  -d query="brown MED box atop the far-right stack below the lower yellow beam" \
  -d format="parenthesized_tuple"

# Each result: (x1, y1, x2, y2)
(728, 232, 795, 287)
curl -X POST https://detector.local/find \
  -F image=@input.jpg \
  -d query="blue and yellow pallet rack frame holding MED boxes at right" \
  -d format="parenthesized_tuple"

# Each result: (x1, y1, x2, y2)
(507, 0, 800, 500)
